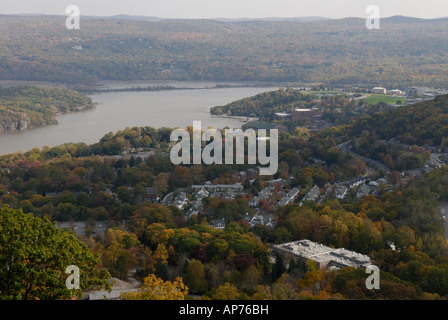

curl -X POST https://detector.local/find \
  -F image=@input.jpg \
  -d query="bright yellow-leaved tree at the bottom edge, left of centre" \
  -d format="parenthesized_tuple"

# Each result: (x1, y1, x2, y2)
(120, 274, 188, 300)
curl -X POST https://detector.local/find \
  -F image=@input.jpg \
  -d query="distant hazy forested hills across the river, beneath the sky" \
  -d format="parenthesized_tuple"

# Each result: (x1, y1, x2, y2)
(0, 16, 448, 88)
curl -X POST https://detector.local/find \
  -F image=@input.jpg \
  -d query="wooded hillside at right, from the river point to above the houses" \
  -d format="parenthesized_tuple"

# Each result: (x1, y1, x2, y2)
(210, 88, 448, 170)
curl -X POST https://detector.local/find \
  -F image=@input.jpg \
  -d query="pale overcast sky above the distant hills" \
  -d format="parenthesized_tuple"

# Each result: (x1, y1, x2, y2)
(0, 0, 448, 19)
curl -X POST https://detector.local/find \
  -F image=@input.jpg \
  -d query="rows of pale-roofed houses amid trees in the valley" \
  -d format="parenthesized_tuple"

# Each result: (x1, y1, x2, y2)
(159, 129, 448, 229)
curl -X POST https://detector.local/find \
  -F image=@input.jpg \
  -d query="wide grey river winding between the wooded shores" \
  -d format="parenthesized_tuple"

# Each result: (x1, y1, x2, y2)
(0, 83, 278, 154)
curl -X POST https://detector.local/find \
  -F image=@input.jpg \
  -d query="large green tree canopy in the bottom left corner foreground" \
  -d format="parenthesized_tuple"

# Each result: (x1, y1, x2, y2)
(0, 207, 110, 300)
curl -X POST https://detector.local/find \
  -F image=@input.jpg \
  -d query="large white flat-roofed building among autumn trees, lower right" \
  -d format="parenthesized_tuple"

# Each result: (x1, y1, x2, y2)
(272, 239, 371, 269)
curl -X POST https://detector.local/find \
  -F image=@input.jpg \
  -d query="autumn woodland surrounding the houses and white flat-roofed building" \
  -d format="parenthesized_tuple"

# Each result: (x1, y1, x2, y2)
(0, 121, 448, 300)
